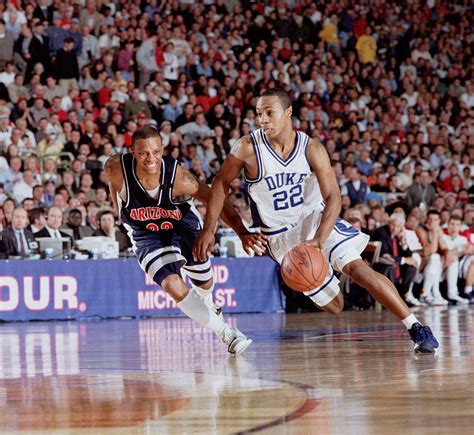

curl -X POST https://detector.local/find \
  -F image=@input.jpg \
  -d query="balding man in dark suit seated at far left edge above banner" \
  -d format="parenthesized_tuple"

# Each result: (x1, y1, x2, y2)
(2, 207, 38, 258)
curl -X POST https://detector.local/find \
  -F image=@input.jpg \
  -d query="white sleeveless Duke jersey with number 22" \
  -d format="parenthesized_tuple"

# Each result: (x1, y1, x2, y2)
(246, 129, 323, 234)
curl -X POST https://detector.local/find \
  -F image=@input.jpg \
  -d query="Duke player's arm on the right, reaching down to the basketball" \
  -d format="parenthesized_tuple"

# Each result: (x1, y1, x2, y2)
(306, 139, 341, 249)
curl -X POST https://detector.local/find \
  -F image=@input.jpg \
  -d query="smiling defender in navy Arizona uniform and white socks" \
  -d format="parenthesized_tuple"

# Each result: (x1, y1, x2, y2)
(105, 127, 261, 354)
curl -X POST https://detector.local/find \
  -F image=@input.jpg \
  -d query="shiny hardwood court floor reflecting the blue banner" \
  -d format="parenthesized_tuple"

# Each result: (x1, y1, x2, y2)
(0, 307, 474, 435)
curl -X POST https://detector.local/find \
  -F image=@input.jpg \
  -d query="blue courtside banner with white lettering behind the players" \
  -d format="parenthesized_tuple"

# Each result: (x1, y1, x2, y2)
(0, 258, 283, 321)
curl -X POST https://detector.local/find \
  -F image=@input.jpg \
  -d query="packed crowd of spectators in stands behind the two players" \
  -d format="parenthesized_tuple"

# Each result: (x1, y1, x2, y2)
(0, 0, 474, 305)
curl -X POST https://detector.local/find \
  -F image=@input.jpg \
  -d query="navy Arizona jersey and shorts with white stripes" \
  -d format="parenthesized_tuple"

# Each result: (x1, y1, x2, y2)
(119, 154, 210, 281)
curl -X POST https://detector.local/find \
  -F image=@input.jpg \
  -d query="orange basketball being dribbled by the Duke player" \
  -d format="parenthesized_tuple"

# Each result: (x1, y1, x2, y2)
(281, 244, 328, 292)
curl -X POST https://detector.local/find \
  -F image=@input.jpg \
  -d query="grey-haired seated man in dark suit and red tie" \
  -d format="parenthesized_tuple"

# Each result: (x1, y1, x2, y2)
(371, 213, 419, 302)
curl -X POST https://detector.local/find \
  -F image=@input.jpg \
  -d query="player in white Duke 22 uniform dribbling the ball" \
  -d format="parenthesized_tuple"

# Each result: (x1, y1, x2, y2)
(193, 89, 439, 353)
